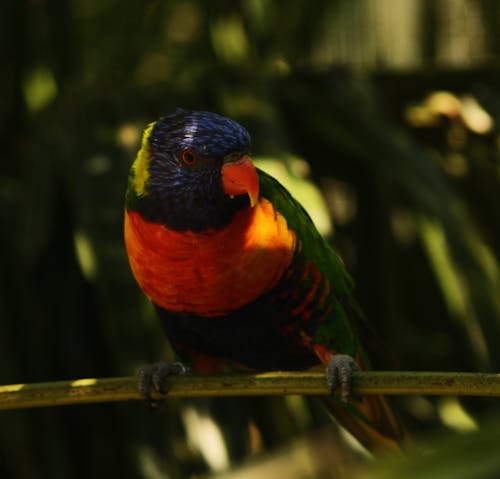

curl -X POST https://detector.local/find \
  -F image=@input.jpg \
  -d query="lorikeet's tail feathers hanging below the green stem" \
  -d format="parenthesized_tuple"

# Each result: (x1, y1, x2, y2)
(323, 390, 409, 454)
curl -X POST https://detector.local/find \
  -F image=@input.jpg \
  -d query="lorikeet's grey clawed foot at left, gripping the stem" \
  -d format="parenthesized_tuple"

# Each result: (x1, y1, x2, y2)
(138, 362, 189, 409)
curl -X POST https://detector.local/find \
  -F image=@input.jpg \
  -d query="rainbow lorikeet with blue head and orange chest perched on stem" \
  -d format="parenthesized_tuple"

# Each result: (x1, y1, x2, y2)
(125, 109, 404, 449)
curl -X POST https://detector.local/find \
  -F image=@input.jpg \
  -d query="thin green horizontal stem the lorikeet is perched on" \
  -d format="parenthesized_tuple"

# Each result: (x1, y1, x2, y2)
(0, 371, 500, 409)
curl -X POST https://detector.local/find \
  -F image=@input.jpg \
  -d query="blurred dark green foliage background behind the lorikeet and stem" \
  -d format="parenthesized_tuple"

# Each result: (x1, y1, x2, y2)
(0, 0, 500, 479)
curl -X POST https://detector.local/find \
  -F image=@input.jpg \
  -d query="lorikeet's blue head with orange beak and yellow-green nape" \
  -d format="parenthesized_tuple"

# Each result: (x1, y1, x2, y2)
(127, 109, 259, 231)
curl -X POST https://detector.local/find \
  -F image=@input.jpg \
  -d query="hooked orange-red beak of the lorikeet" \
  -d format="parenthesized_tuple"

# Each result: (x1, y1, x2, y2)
(221, 155, 259, 208)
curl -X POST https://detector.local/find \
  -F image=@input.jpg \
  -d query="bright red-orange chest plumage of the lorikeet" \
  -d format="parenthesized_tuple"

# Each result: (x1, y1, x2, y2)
(125, 198, 296, 316)
